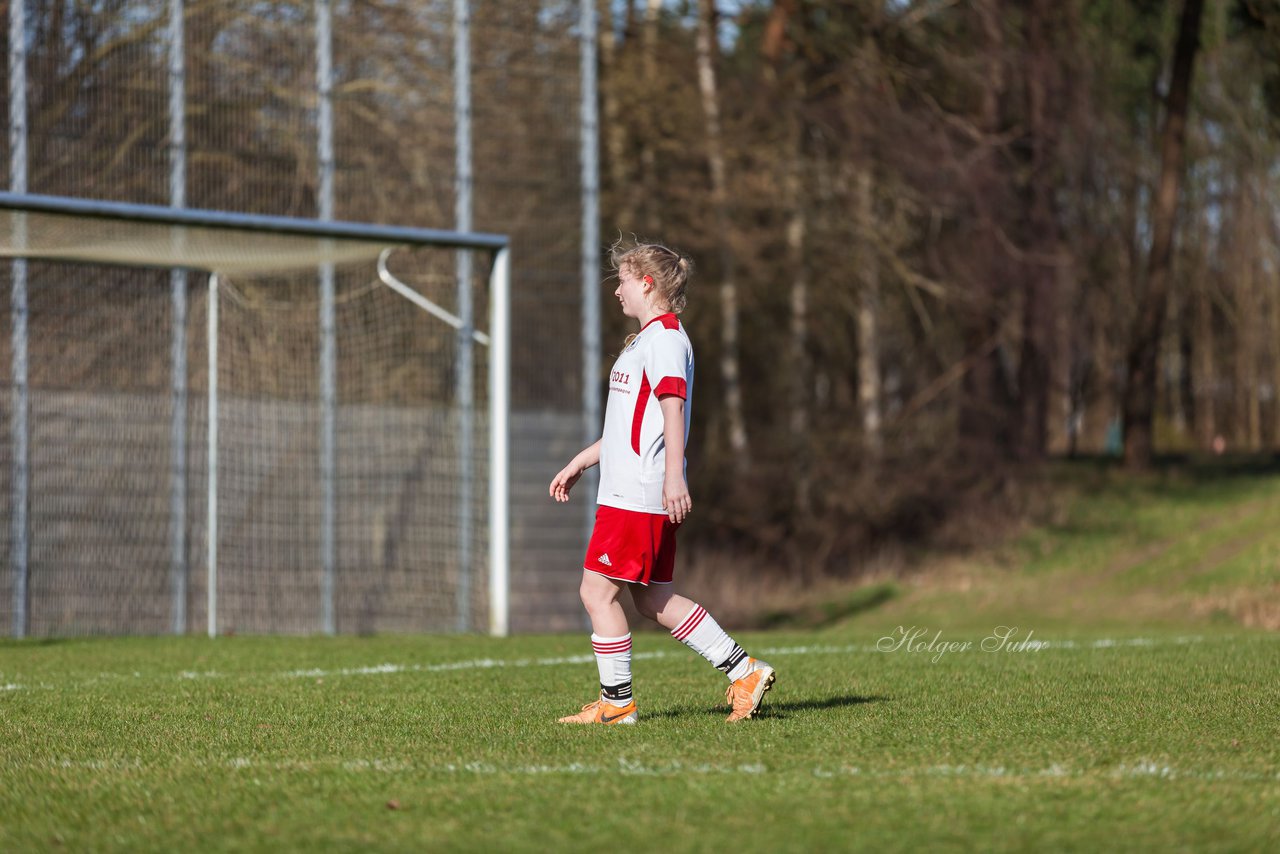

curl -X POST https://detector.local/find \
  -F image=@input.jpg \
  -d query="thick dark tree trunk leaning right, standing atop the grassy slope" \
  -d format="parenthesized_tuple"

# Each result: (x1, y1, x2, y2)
(1124, 0, 1204, 470)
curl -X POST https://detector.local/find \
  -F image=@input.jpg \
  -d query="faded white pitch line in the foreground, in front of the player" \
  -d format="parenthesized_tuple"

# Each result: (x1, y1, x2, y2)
(22, 757, 1280, 782)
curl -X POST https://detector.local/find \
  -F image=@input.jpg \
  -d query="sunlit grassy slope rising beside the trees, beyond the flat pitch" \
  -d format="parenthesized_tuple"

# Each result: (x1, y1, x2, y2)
(874, 465, 1280, 630)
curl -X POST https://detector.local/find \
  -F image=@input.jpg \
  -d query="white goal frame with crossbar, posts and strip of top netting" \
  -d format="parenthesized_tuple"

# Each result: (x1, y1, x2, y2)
(0, 192, 511, 635)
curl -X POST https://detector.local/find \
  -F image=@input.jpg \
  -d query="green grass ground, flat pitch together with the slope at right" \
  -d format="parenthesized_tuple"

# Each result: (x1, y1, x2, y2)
(0, 463, 1280, 851)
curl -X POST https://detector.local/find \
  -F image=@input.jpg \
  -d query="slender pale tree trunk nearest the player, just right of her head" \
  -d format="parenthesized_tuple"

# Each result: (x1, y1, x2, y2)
(698, 0, 750, 463)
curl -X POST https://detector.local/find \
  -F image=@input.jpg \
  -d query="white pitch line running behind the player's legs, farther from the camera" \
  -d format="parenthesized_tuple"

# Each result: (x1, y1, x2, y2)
(0, 635, 1244, 691)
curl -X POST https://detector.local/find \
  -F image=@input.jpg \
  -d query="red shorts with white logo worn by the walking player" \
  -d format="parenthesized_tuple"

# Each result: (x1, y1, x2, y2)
(582, 504, 680, 584)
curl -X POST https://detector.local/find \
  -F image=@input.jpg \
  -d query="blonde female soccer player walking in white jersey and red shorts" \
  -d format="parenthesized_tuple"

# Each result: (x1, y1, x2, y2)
(550, 243, 774, 723)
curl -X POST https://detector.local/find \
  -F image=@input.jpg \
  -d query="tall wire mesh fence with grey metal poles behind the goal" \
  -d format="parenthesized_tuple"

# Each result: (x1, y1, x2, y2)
(0, 0, 599, 634)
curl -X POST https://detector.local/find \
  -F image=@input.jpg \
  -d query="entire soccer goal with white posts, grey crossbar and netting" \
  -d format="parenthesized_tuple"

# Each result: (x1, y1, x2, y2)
(0, 193, 509, 636)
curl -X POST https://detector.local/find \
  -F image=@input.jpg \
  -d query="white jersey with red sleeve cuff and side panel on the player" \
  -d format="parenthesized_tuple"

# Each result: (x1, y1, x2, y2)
(596, 314, 694, 513)
